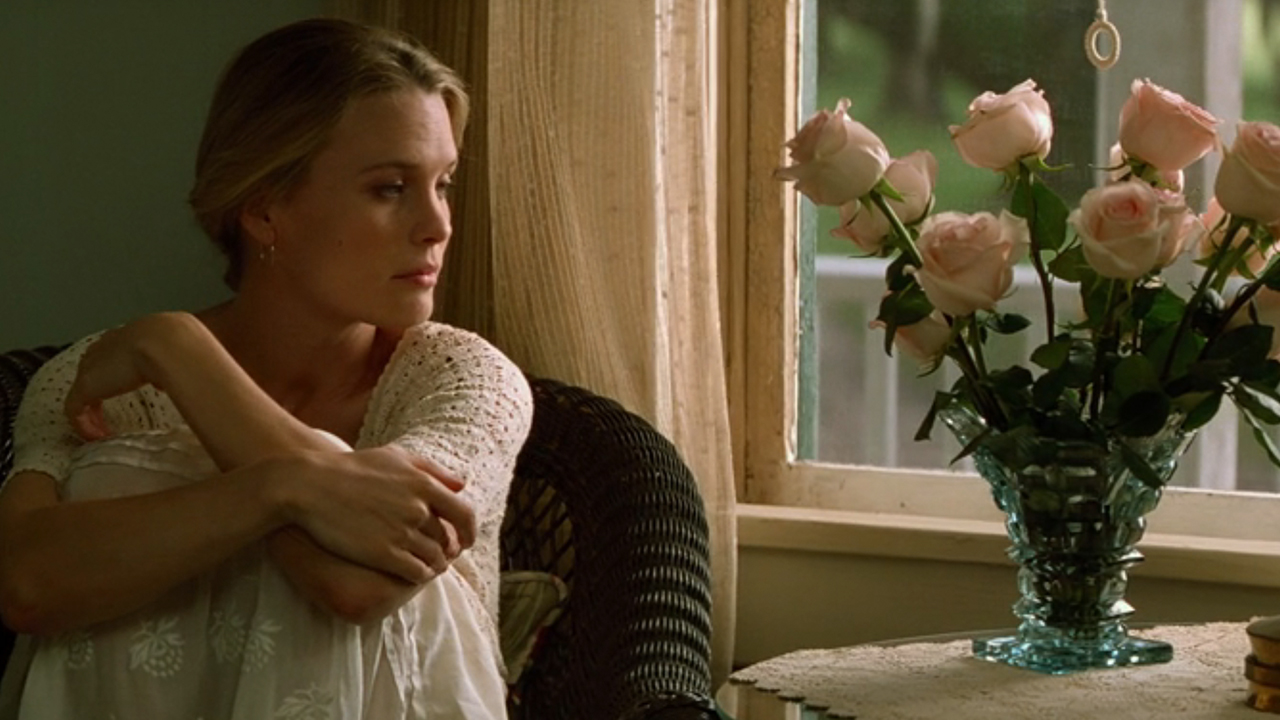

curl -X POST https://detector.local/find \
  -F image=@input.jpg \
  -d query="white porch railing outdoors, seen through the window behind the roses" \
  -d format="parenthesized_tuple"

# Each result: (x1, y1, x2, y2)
(814, 256, 1280, 492)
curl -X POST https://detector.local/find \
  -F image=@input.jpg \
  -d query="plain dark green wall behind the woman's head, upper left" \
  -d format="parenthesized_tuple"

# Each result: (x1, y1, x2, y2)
(0, 0, 324, 351)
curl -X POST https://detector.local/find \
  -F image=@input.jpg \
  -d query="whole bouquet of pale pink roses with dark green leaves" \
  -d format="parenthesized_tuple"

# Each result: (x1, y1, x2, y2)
(777, 81, 1280, 484)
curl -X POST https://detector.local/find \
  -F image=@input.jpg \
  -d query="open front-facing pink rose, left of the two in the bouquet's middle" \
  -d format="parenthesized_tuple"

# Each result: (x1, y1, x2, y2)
(915, 211, 1030, 316)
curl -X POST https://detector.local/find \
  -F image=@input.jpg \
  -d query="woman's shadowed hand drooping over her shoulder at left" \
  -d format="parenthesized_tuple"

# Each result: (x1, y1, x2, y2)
(64, 313, 198, 441)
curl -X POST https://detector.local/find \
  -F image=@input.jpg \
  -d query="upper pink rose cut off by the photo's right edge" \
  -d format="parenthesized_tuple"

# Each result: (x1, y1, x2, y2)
(1213, 123, 1280, 225)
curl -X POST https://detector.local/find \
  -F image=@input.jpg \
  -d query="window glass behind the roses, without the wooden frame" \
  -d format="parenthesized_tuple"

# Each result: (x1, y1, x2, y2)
(799, 0, 1280, 491)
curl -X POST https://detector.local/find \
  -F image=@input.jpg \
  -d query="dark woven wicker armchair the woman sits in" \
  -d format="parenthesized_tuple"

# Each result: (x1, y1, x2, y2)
(0, 347, 717, 720)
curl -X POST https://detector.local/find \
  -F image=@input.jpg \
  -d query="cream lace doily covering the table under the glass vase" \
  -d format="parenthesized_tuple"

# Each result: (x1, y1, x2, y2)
(731, 623, 1266, 720)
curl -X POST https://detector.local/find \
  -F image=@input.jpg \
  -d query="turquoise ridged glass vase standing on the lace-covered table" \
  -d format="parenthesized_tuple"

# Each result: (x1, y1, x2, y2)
(941, 407, 1192, 675)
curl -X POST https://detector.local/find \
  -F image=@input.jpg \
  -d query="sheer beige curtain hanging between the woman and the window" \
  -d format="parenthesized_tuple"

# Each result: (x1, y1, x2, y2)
(337, 0, 737, 684)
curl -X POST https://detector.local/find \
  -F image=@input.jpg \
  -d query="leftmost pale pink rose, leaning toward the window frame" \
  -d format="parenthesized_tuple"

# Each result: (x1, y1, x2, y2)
(774, 99, 890, 205)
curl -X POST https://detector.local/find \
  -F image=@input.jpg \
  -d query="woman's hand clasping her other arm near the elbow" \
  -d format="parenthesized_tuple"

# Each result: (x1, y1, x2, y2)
(275, 445, 476, 584)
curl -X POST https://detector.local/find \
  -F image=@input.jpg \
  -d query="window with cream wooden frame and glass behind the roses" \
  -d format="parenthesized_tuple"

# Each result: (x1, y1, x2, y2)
(724, 0, 1280, 541)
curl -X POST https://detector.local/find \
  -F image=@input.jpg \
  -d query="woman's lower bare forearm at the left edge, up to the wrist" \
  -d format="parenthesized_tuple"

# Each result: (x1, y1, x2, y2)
(0, 465, 288, 634)
